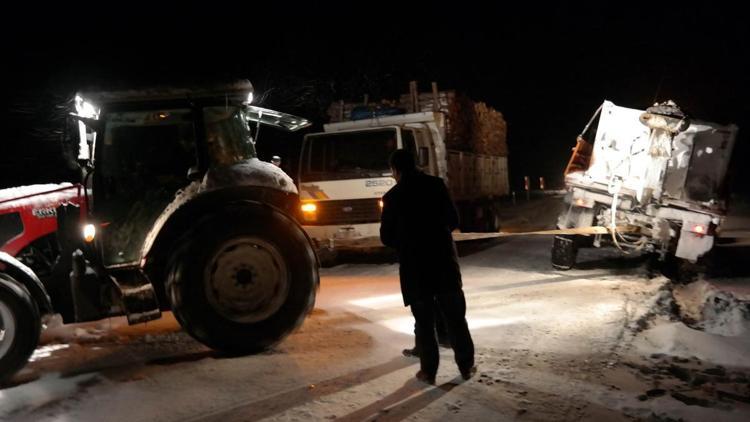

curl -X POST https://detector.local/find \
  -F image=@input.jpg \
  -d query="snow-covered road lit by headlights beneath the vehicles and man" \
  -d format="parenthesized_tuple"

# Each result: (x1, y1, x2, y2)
(0, 238, 750, 422)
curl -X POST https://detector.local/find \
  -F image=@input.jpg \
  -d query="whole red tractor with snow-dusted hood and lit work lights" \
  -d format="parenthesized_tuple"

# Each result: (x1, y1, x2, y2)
(0, 81, 319, 381)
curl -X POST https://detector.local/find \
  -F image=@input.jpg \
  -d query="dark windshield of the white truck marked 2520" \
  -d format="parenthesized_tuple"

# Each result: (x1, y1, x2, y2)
(300, 128, 397, 182)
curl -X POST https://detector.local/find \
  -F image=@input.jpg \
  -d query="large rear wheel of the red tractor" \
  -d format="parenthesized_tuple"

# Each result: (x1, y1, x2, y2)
(166, 205, 319, 354)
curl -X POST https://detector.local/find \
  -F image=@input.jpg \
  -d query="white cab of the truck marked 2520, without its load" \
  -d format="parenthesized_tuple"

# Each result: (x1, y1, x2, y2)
(297, 112, 446, 248)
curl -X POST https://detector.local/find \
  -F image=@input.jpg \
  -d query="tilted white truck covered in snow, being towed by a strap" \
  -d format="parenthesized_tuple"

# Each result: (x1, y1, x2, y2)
(552, 101, 737, 269)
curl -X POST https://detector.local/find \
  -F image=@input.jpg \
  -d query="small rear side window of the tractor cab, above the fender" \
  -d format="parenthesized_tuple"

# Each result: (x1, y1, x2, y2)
(203, 107, 255, 166)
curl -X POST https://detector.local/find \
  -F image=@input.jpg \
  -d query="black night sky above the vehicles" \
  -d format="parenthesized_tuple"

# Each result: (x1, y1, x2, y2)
(0, 2, 750, 195)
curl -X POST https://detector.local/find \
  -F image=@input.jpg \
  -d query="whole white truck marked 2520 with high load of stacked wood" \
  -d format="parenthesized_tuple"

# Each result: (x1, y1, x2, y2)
(297, 86, 509, 251)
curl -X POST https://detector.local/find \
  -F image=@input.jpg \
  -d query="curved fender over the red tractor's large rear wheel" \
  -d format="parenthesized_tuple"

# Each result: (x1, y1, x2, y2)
(141, 186, 312, 268)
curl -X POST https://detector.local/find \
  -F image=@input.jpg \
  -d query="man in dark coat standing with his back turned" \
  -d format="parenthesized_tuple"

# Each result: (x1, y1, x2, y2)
(380, 149, 476, 384)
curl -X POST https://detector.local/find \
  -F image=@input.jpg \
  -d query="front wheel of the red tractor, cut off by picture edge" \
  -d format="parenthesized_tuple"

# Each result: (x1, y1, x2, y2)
(0, 273, 42, 383)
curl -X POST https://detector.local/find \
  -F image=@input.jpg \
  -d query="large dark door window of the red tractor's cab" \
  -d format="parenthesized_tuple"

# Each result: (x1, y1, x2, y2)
(94, 110, 197, 265)
